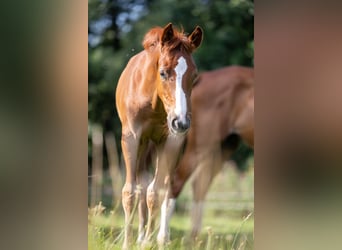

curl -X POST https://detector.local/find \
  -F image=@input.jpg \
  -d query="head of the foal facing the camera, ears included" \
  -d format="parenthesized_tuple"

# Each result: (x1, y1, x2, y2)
(158, 24, 202, 135)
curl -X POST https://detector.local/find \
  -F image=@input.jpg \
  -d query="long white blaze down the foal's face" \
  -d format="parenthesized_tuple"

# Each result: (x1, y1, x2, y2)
(175, 56, 188, 121)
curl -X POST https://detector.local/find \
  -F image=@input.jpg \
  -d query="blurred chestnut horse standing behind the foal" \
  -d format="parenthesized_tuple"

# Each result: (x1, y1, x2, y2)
(168, 66, 254, 237)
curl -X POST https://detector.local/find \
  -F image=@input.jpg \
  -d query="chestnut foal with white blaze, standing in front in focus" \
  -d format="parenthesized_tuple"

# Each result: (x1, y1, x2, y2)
(116, 23, 203, 249)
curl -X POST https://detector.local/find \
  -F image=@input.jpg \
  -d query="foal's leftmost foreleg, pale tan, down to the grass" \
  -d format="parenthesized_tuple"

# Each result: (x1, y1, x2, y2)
(121, 136, 138, 249)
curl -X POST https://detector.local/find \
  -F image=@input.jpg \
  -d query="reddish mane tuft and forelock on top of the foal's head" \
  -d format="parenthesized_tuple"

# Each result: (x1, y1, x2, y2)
(142, 27, 192, 53)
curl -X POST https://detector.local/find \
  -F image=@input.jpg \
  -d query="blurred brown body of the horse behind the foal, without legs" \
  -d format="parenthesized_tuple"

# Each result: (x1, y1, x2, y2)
(192, 66, 254, 144)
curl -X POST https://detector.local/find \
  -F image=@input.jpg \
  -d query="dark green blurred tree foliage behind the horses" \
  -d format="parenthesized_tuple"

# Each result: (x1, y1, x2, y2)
(88, 0, 254, 166)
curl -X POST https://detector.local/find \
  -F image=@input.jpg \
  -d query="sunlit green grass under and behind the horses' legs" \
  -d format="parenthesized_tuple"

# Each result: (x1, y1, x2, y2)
(88, 163, 254, 250)
